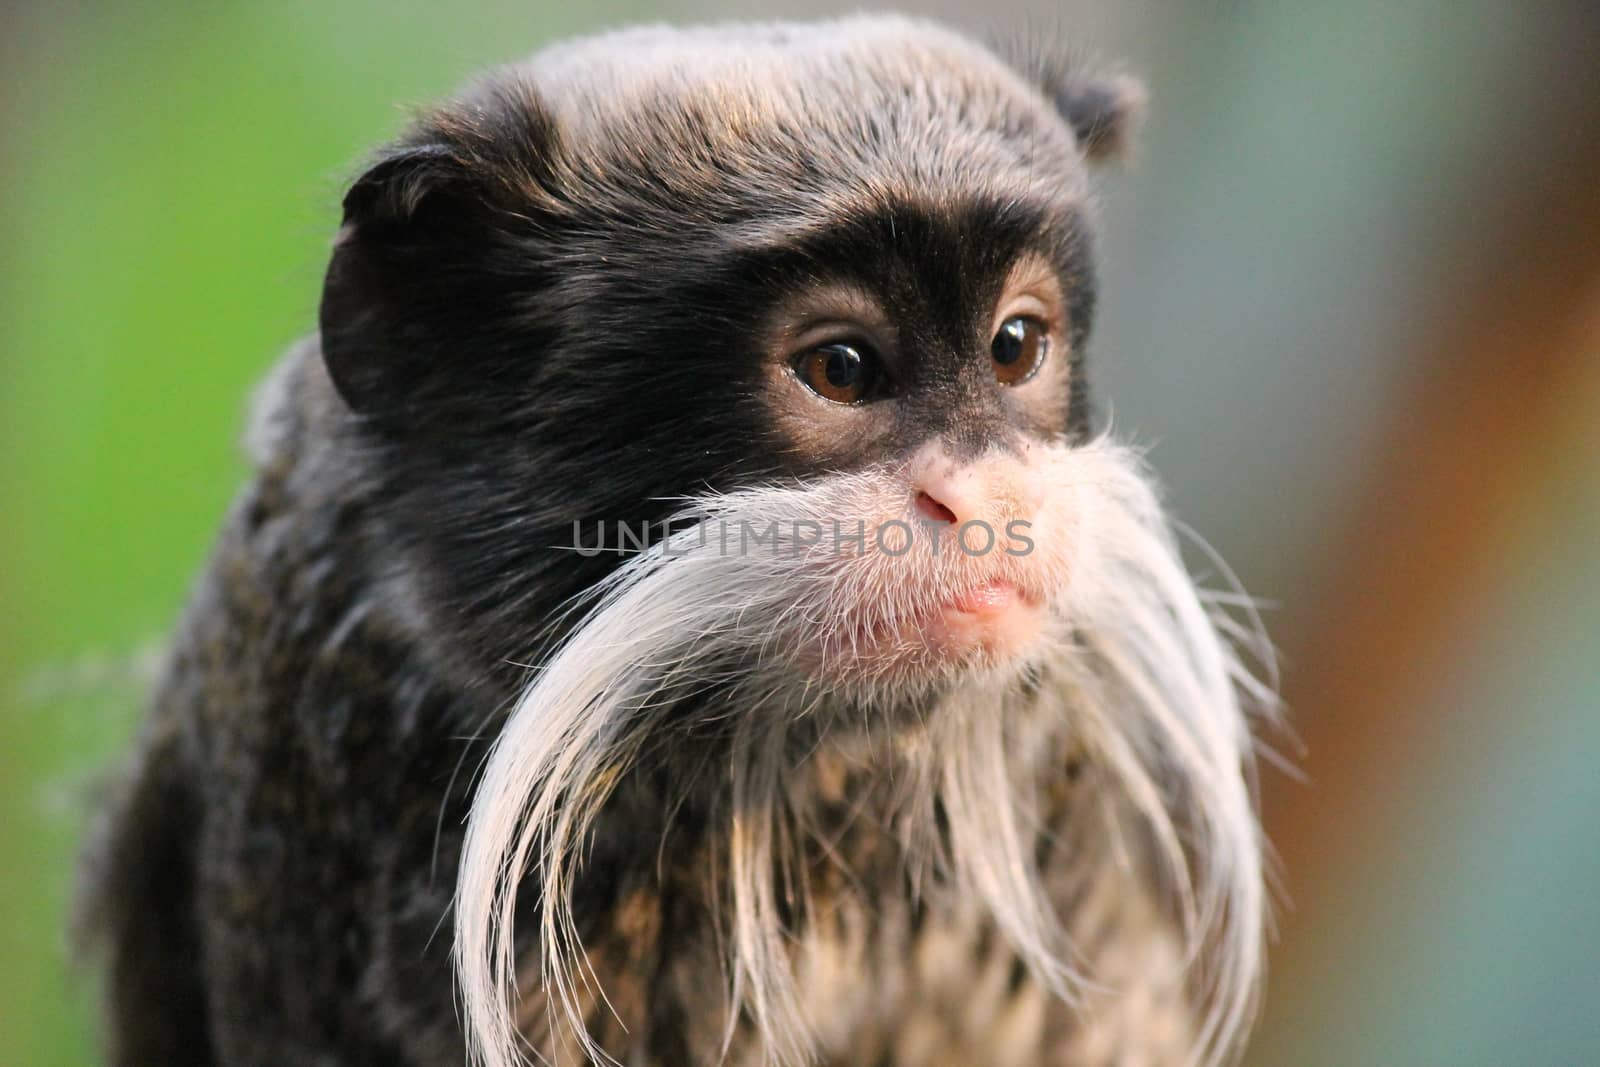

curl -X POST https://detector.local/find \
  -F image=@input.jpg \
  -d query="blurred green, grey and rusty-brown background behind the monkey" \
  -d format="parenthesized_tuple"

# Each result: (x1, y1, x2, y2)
(0, 0, 1600, 1067)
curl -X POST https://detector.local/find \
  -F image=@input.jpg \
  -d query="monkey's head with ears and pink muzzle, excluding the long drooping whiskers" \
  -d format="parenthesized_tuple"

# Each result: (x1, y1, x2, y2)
(322, 19, 1141, 691)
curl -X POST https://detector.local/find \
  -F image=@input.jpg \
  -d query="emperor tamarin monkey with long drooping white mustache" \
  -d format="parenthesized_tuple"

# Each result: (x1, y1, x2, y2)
(80, 18, 1270, 1067)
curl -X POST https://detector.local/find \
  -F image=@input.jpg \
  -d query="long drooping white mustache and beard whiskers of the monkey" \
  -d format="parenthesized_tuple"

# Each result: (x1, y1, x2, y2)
(454, 440, 1272, 1067)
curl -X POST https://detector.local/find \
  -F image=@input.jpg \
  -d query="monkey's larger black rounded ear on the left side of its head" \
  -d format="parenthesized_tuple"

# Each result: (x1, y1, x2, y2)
(318, 144, 485, 414)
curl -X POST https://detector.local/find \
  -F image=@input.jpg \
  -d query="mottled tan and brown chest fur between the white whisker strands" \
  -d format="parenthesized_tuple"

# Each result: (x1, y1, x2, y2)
(518, 710, 1194, 1067)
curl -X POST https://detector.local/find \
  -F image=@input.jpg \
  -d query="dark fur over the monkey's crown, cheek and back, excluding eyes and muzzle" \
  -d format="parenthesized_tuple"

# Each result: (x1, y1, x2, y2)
(82, 21, 1152, 1065)
